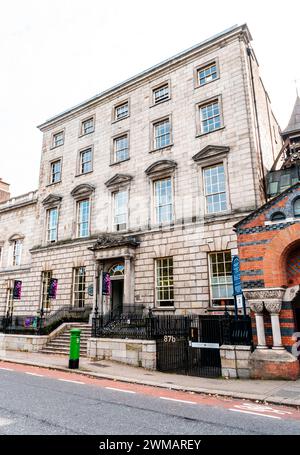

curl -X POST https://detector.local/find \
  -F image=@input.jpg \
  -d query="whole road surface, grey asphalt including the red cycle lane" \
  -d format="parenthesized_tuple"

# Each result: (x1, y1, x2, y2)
(0, 362, 300, 436)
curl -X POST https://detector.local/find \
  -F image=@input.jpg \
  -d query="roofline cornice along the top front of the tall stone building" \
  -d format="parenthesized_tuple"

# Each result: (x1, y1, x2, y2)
(37, 23, 252, 129)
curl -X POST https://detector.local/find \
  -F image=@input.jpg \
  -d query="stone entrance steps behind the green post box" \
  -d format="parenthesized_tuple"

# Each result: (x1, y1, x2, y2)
(40, 323, 92, 357)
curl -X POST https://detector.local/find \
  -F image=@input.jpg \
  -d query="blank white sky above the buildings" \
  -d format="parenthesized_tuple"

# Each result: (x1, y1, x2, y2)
(0, 0, 300, 196)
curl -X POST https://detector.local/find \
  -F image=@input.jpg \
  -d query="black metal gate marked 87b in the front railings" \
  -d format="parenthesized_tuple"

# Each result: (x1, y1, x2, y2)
(156, 316, 223, 377)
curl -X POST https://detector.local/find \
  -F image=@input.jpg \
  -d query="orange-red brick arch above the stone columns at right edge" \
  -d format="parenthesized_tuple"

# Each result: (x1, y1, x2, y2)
(263, 223, 300, 288)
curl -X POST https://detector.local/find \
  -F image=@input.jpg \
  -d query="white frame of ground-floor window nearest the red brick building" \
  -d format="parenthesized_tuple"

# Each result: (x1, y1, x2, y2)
(208, 250, 234, 308)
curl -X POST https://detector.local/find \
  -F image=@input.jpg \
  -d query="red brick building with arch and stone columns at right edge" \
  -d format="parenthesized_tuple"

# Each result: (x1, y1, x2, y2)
(235, 97, 300, 378)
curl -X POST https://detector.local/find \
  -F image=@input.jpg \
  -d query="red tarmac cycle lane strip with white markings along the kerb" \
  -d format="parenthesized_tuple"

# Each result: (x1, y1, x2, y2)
(0, 361, 300, 420)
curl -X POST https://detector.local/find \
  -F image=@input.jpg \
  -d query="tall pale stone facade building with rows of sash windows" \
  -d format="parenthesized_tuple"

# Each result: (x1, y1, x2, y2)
(0, 25, 282, 322)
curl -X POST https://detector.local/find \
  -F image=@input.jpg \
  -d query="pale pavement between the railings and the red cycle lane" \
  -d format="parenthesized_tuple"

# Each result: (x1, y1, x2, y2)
(0, 351, 300, 408)
